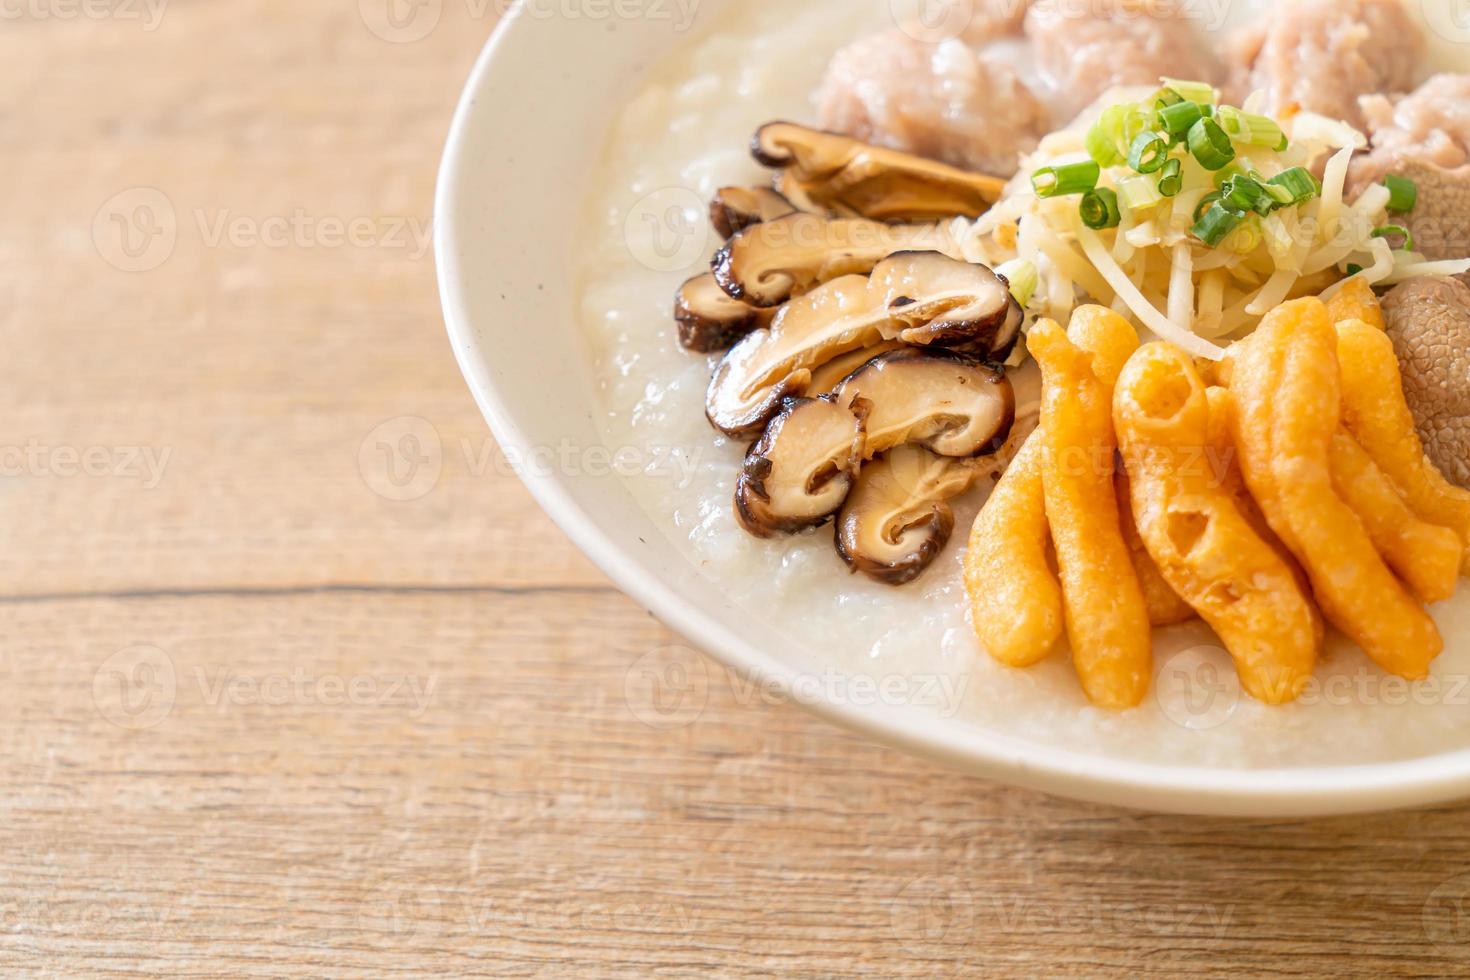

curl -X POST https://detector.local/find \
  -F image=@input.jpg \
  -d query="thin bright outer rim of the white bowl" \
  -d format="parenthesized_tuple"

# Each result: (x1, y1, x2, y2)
(434, 7, 1470, 817)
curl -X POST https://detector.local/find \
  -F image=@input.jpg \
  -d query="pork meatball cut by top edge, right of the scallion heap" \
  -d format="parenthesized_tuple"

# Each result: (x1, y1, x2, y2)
(1230, 0, 1423, 128)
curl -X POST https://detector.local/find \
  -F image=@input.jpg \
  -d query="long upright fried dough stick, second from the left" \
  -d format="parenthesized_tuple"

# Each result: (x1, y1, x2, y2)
(1026, 320, 1152, 708)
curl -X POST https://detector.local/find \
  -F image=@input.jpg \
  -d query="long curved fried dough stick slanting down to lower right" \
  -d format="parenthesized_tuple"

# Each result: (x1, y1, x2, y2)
(1230, 298, 1444, 680)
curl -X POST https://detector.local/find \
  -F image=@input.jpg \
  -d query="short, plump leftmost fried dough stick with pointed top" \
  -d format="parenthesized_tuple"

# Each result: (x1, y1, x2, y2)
(964, 432, 1061, 667)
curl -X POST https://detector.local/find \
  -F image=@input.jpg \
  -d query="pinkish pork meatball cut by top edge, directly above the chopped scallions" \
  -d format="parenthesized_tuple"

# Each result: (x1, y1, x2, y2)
(1025, 0, 1223, 119)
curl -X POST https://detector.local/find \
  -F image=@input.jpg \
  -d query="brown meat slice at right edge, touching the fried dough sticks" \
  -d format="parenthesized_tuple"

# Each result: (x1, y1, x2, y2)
(1383, 276, 1470, 488)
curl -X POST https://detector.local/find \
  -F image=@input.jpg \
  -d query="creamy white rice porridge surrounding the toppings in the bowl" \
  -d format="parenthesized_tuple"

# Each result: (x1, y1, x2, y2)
(575, 0, 1470, 767)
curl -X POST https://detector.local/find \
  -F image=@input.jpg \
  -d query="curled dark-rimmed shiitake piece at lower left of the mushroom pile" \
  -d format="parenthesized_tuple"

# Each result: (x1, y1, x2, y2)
(735, 398, 863, 538)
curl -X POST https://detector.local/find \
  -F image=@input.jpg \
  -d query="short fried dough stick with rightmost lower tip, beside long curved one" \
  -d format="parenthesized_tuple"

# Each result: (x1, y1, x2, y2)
(1330, 428, 1464, 602)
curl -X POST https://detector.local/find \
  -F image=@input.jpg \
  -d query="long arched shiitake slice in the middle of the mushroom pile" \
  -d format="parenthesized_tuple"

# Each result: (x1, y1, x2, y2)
(706, 253, 1019, 436)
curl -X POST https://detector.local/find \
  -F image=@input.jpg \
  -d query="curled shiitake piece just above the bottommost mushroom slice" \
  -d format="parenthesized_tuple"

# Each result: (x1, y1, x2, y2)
(833, 347, 1016, 458)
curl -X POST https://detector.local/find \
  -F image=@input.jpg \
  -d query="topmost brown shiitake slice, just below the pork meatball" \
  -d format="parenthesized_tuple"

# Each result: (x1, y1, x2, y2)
(751, 122, 1005, 222)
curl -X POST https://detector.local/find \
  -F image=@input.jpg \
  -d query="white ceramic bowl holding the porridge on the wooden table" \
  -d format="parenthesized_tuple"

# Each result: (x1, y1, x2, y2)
(434, 0, 1470, 815)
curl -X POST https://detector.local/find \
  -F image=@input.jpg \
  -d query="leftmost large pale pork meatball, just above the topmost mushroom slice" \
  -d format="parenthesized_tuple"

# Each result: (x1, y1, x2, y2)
(814, 29, 1050, 176)
